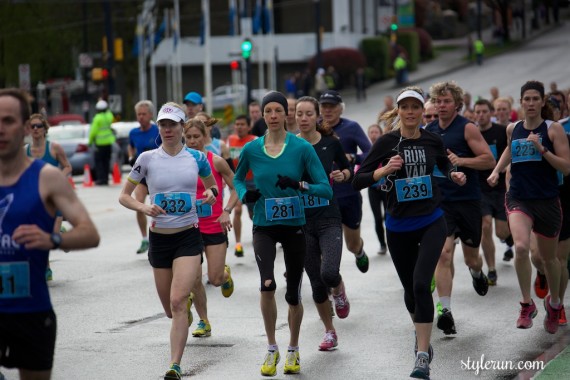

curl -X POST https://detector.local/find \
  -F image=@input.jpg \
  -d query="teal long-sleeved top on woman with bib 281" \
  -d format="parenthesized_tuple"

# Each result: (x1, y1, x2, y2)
(234, 133, 332, 226)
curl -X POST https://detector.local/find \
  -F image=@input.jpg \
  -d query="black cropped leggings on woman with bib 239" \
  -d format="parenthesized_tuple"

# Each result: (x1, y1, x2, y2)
(387, 216, 447, 323)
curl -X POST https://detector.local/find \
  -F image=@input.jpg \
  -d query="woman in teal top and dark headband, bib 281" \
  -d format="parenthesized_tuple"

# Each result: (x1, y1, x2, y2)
(234, 91, 332, 376)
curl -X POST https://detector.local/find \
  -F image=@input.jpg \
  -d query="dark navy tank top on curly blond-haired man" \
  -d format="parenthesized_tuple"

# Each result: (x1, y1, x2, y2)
(425, 115, 481, 202)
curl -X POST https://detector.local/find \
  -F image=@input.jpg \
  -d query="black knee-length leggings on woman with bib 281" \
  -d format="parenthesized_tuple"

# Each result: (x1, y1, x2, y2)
(253, 225, 306, 305)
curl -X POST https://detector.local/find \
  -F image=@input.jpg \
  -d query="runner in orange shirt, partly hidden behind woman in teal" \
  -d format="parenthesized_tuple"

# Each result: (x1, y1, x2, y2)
(228, 113, 259, 257)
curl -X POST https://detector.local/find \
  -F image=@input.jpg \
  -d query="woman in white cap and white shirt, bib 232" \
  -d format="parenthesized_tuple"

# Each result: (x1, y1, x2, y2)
(119, 103, 219, 380)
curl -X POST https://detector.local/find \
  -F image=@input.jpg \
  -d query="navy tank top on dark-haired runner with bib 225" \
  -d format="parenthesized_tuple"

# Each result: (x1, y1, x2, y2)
(509, 120, 558, 200)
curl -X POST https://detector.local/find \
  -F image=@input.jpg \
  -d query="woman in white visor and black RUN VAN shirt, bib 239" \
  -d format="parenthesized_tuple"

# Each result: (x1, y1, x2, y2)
(353, 87, 466, 379)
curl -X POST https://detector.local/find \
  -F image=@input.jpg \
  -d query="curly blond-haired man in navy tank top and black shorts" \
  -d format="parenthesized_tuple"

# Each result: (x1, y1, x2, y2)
(426, 81, 495, 335)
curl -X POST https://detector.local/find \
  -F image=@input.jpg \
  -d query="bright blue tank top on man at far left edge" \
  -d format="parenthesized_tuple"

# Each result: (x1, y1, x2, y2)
(0, 160, 55, 313)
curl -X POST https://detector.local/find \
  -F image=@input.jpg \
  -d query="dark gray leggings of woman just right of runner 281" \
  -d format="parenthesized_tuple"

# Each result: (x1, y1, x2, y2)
(305, 218, 342, 303)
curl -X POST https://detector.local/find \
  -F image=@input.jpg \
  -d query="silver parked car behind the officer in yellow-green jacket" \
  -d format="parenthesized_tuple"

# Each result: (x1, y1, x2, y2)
(47, 124, 122, 180)
